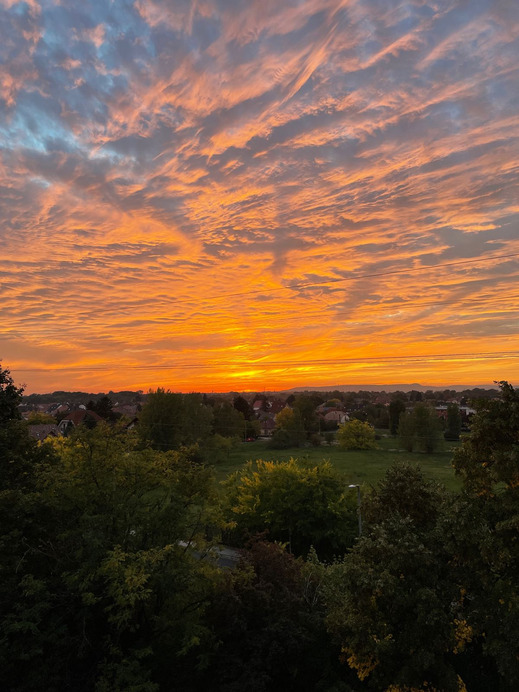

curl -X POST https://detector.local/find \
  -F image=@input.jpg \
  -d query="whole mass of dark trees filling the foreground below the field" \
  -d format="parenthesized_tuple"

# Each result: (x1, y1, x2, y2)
(0, 370, 519, 692)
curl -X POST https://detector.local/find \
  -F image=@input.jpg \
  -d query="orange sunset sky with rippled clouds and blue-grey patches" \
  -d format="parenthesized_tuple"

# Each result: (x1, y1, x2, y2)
(0, 0, 519, 392)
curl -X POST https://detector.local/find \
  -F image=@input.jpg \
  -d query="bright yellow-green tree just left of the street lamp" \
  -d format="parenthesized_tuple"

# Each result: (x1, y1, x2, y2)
(224, 459, 356, 558)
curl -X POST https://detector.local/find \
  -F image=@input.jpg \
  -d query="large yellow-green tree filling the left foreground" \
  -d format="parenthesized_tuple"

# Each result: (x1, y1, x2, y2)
(0, 424, 221, 692)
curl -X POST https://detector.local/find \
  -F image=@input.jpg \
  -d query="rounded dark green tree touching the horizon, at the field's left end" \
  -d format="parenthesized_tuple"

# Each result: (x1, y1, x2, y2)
(139, 389, 213, 452)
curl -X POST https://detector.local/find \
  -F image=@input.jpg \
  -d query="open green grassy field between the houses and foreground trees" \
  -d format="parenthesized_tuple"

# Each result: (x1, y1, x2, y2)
(215, 437, 461, 490)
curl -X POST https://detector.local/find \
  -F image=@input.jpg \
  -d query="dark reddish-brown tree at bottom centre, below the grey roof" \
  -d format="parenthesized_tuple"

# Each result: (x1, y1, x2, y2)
(195, 541, 346, 692)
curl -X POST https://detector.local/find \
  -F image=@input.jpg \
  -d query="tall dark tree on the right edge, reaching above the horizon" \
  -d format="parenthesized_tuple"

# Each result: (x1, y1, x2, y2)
(444, 381, 519, 690)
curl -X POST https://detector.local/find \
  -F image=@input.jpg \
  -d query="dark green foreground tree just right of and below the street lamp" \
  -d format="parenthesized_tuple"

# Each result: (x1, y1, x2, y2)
(325, 465, 464, 692)
